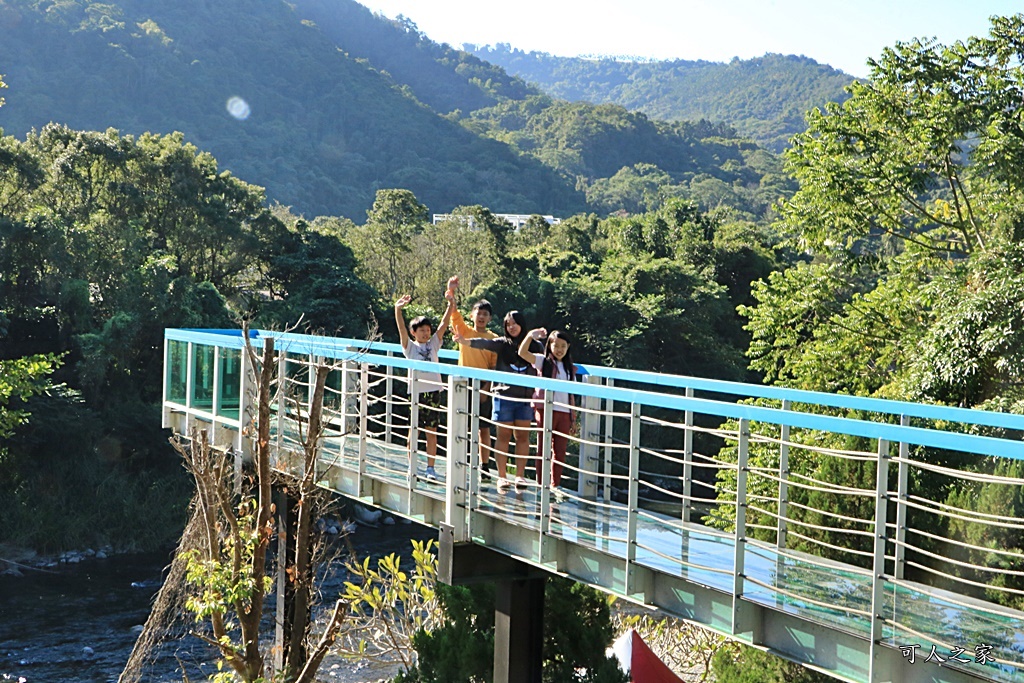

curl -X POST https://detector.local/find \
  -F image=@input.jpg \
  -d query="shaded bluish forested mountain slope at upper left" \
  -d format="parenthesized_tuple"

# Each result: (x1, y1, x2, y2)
(0, 0, 585, 220)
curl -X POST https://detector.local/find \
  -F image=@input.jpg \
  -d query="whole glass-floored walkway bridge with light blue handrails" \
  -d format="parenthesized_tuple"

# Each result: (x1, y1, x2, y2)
(163, 330, 1024, 683)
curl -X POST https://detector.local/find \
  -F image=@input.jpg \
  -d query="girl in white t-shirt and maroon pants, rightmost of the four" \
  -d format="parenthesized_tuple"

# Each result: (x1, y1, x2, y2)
(519, 328, 575, 499)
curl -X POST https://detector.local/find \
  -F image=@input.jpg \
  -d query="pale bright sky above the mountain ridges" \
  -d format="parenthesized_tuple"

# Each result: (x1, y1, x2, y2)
(362, 0, 1024, 76)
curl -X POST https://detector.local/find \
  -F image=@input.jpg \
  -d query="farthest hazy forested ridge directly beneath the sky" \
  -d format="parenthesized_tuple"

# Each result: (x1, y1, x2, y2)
(465, 44, 854, 152)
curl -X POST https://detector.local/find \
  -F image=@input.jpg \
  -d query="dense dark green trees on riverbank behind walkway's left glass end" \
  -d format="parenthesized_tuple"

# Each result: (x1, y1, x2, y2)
(0, 125, 375, 550)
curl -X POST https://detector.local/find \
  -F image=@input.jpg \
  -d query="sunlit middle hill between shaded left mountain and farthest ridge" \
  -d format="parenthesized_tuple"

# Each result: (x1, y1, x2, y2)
(463, 95, 796, 221)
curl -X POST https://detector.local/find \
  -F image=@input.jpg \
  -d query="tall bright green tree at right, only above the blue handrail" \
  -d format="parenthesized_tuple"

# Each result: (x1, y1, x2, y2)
(743, 15, 1024, 405)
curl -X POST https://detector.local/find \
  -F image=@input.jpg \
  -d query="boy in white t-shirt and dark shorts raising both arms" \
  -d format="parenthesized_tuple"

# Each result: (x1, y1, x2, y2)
(394, 294, 455, 479)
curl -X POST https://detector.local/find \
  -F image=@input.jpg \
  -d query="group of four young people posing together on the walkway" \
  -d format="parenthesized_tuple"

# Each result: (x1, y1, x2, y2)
(394, 276, 577, 498)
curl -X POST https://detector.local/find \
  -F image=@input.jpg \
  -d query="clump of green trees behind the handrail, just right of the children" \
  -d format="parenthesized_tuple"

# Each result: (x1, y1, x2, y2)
(484, 200, 775, 379)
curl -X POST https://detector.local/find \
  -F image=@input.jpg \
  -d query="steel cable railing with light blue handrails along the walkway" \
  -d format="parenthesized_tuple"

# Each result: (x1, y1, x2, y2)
(165, 332, 1024, 683)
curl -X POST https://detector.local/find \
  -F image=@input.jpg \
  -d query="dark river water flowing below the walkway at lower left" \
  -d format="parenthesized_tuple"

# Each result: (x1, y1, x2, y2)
(0, 523, 437, 683)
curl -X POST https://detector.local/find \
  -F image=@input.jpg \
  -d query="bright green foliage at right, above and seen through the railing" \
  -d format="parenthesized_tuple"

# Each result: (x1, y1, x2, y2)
(719, 14, 1024, 603)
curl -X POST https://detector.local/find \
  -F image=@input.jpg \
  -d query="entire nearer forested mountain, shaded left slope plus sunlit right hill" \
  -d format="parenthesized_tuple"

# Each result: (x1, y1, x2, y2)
(0, 0, 781, 220)
